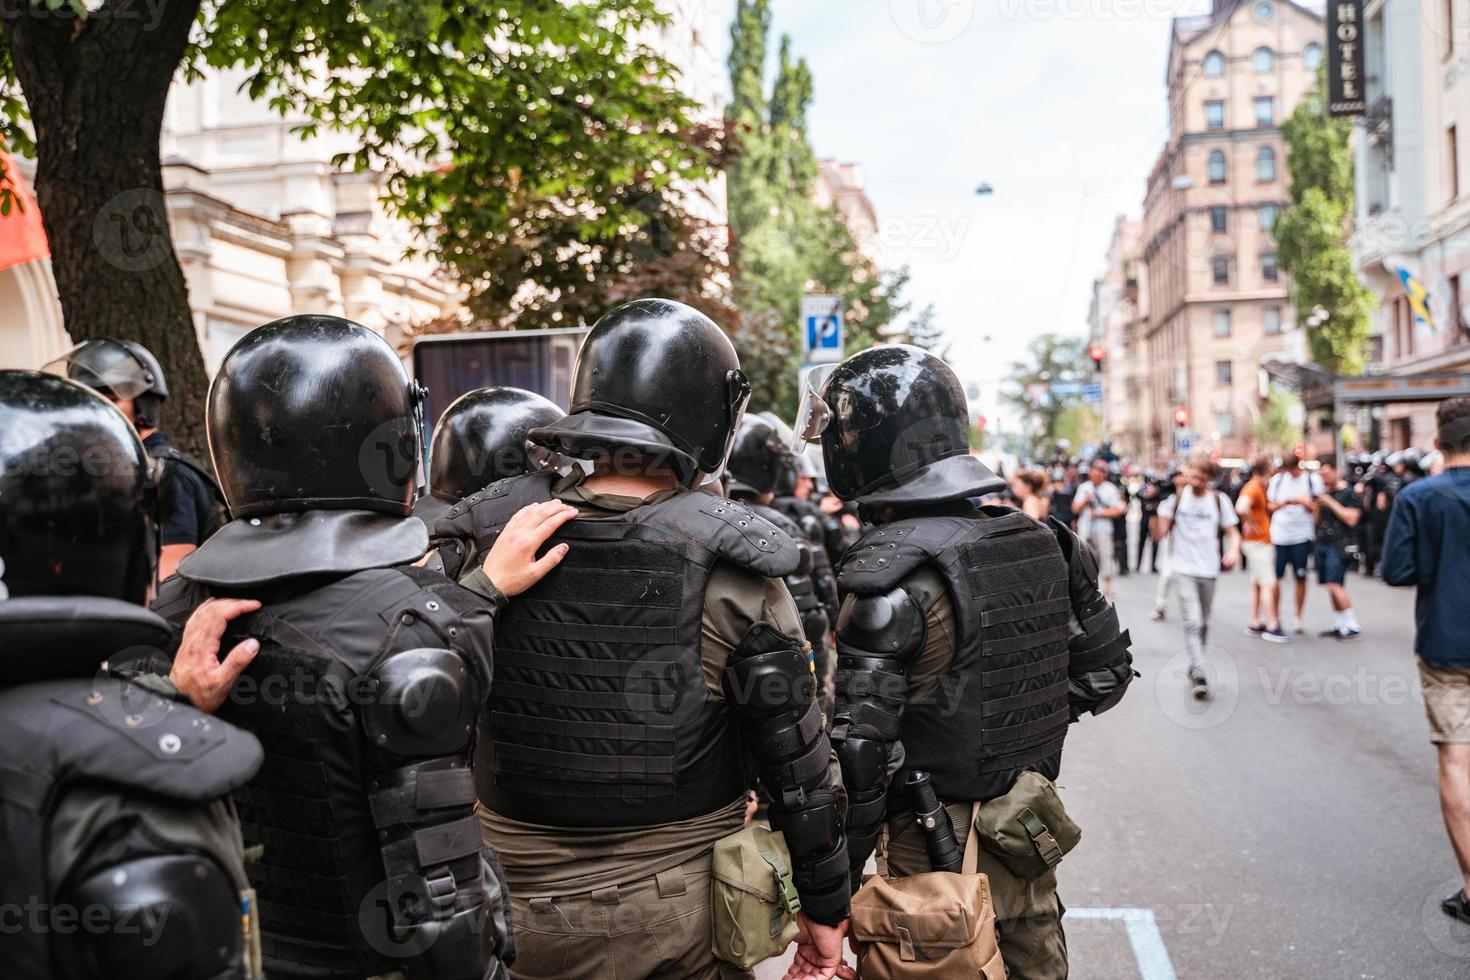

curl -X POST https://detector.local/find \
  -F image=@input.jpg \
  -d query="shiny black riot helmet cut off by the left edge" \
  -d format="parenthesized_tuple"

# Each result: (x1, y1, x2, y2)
(0, 370, 159, 604)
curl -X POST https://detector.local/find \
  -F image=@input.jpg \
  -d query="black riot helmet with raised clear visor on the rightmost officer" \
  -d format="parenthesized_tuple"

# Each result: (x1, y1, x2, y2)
(797, 345, 1005, 507)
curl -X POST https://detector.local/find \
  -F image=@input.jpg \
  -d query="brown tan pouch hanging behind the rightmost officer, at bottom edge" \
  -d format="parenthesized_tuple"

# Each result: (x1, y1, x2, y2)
(851, 811, 1005, 980)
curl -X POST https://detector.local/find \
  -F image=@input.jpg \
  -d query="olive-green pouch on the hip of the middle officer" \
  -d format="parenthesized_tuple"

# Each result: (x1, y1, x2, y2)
(710, 824, 801, 967)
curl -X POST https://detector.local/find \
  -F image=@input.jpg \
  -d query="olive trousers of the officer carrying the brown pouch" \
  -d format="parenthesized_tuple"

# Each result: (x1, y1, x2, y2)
(888, 804, 1067, 980)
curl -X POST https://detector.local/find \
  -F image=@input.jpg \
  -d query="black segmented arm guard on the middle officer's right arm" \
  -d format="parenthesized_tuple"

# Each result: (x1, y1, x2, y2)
(725, 623, 850, 926)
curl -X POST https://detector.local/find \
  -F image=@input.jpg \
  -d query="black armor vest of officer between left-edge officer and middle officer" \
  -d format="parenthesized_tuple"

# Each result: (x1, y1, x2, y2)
(154, 567, 492, 980)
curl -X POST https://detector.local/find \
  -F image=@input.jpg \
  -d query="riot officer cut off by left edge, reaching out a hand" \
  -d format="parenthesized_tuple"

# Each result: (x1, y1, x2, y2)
(0, 370, 262, 980)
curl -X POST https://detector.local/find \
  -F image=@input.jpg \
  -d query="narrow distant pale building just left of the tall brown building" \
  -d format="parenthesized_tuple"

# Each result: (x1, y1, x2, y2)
(1088, 215, 1150, 457)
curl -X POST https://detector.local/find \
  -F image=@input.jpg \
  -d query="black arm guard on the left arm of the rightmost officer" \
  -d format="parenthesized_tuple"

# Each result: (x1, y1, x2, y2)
(832, 588, 925, 882)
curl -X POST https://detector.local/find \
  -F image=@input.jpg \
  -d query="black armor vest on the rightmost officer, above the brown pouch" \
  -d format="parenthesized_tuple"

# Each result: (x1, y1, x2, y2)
(838, 508, 1072, 807)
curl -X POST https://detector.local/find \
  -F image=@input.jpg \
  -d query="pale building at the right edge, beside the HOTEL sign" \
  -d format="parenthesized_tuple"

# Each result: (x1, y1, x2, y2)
(1351, 0, 1470, 450)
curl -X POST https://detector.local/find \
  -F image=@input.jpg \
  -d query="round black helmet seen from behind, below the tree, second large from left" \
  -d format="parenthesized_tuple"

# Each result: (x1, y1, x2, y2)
(209, 314, 423, 520)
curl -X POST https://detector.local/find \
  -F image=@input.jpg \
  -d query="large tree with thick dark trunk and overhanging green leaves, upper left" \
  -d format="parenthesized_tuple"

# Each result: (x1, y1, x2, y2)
(0, 0, 693, 450)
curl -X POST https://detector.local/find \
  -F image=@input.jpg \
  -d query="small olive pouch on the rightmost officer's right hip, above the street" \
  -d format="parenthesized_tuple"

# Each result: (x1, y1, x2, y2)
(976, 773, 1082, 882)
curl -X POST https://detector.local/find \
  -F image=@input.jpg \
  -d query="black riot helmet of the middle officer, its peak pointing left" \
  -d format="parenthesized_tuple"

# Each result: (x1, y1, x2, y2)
(531, 300, 750, 486)
